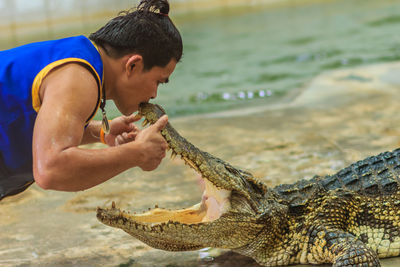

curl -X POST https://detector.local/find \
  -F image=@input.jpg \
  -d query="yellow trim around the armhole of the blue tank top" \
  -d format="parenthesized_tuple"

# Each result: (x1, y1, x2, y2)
(32, 58, 103, 122)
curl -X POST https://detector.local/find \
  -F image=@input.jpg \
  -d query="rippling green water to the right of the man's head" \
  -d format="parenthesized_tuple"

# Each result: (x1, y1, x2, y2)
(146, 0, 400, 115)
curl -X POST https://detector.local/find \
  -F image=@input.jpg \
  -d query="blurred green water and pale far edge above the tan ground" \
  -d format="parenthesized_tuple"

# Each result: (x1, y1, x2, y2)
(0, 0, 400, 117)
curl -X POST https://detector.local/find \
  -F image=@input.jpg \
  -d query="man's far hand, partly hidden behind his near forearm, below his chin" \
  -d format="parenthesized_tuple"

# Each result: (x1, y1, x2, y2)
(104, 114, 140, 146)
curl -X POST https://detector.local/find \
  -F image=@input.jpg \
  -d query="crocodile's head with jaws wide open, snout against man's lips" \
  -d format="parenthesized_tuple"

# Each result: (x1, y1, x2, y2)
(97, 103, 286, 251)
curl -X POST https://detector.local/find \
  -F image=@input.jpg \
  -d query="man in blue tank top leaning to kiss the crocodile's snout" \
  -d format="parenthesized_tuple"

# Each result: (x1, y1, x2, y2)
(0, 0, 182, 199)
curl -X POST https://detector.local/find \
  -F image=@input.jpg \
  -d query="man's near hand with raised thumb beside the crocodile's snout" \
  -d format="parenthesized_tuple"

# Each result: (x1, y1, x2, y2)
(135, 115, 168, 171)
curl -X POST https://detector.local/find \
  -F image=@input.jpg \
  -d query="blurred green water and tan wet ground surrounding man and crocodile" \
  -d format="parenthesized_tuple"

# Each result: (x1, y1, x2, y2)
(0, 0, 400, 267)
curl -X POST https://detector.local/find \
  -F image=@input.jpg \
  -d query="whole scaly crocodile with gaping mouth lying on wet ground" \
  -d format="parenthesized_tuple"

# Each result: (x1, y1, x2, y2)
(97, 104, 400, 267)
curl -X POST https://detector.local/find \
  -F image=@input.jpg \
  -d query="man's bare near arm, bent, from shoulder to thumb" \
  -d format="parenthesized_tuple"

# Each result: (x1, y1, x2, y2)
(33, 64, 168, 191)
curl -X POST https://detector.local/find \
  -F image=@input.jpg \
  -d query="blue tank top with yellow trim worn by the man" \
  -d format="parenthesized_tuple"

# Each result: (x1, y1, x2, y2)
(0, 36, 103, 177)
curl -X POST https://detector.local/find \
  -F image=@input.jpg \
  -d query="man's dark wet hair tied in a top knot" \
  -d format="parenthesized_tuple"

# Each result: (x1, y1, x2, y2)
(89, 0, 183, 70)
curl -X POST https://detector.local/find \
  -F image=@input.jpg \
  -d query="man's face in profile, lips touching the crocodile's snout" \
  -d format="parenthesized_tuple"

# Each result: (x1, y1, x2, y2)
(114, 59, 177, 115)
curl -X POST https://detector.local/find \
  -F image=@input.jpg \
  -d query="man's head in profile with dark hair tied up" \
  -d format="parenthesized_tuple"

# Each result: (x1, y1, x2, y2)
(89, 0, 183, 115)
